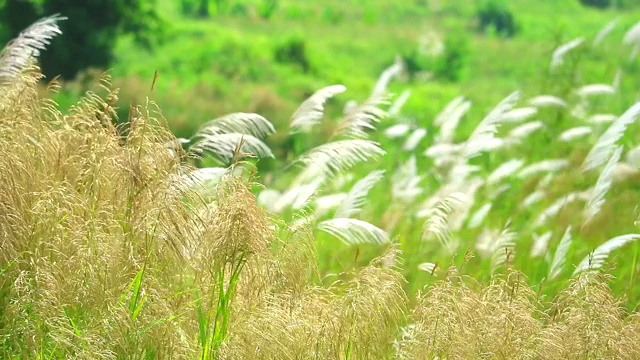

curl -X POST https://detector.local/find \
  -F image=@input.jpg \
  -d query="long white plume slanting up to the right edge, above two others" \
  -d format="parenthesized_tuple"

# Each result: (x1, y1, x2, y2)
(582, 102, 640, 171)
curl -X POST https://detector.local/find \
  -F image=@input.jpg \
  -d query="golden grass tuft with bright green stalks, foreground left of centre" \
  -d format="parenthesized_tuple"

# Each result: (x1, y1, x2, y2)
(194, 178, 273, 359)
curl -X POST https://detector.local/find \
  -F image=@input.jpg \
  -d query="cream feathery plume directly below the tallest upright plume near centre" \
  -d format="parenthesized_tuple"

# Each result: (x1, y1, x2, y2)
(332, 93, 388, 139)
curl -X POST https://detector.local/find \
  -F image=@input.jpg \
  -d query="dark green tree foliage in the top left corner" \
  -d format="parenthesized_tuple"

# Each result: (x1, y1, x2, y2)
(0, 0, 160, 79)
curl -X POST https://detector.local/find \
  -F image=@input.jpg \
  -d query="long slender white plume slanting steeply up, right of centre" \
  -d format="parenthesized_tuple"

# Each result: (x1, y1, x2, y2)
(462, 91, 520, 159)
